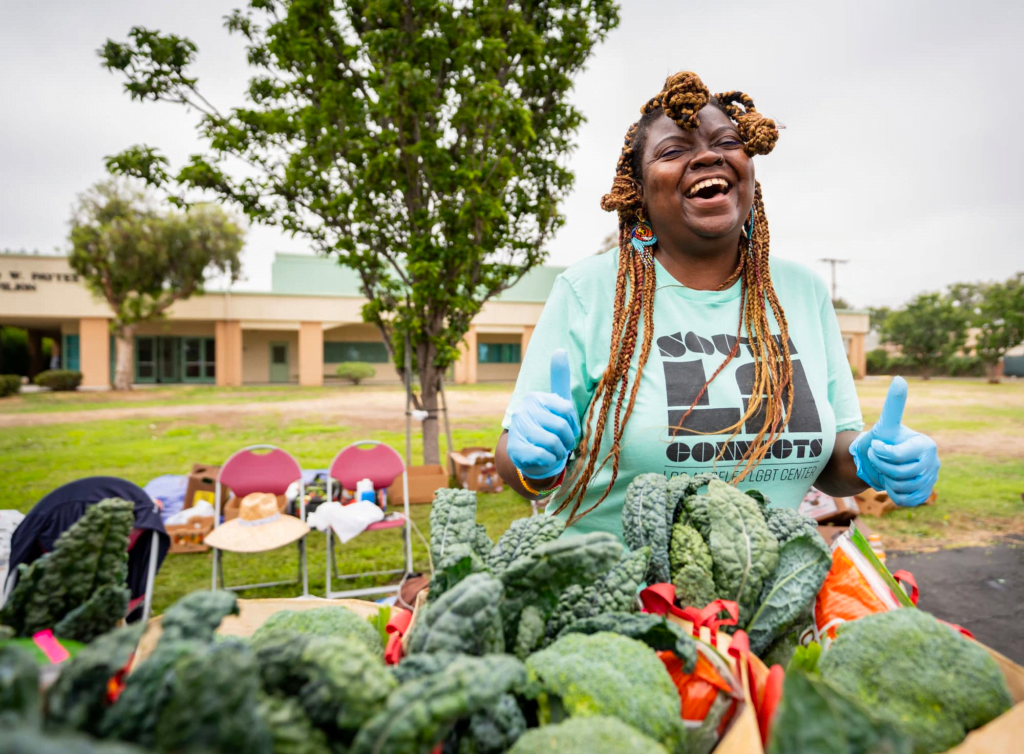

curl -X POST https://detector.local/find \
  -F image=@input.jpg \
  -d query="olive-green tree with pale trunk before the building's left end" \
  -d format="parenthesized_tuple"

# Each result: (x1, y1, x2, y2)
(70, 180, 243, 390)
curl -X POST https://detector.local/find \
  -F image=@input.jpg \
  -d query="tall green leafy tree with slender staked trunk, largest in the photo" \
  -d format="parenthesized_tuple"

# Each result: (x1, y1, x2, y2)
(100, 0, 618, 463)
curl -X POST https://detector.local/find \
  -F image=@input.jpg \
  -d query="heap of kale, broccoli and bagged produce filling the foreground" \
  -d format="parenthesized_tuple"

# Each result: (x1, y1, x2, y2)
(0, 474, 1024, 754)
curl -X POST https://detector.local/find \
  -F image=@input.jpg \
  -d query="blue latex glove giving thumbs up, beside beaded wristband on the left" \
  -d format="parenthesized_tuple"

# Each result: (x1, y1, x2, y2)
(506, 348, 580, 479)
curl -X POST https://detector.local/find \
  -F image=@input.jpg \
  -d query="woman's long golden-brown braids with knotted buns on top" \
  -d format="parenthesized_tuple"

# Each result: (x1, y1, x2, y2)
(555, 72, 793, 526)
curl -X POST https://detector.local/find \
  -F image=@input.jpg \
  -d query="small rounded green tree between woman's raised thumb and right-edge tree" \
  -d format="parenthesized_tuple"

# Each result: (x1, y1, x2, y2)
(882, 293, 968, 380)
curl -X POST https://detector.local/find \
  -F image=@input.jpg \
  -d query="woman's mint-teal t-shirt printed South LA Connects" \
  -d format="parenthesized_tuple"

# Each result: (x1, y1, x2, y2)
(502, 251, 863, 538)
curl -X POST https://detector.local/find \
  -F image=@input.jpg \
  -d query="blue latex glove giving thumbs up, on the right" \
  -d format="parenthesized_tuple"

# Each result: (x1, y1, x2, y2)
(850, 377, 940, 507)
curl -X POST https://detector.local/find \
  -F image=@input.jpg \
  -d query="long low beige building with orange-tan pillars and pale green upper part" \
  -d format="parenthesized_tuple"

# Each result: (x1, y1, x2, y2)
(0, 254, 867, 388)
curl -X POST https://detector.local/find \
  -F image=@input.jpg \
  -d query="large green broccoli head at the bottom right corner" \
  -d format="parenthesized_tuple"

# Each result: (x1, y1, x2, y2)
(818, 608, 1012, 754)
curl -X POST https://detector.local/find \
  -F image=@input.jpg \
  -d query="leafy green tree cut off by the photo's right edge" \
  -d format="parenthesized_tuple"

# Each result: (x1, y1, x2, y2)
(971, 273, 1024, 383)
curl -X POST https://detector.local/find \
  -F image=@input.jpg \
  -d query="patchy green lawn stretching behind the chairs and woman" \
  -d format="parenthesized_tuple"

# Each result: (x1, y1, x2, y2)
(0, 380, 1024, 610)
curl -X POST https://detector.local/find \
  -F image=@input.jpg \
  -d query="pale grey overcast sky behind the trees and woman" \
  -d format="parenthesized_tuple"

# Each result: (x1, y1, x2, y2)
(0, 0, 1024, 306)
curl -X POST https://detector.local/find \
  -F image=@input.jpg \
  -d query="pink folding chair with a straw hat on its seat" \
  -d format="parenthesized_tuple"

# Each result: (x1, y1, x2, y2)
(207, 445, 309, 596)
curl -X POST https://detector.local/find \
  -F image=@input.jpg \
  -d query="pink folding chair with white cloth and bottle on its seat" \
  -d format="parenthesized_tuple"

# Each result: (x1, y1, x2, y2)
(326, 439, 413, 599)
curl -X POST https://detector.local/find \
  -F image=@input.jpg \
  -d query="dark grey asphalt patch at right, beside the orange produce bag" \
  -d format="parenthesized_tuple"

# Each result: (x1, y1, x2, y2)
(886, 539, 1024, 665)
